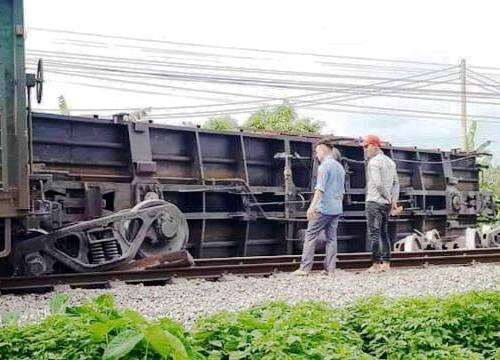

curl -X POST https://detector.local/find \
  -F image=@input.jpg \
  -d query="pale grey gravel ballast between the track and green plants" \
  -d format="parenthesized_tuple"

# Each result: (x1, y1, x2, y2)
(0, 264, 500, 326)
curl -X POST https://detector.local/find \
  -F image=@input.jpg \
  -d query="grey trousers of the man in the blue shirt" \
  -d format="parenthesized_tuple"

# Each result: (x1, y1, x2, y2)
(300, 212, 340, 272)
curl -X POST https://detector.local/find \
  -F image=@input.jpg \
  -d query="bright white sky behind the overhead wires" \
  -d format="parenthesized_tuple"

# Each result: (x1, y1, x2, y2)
(25, 0, 500, 159)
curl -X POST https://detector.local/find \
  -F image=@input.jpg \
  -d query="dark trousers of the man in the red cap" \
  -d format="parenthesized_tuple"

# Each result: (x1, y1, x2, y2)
(366, 201, 391, 262)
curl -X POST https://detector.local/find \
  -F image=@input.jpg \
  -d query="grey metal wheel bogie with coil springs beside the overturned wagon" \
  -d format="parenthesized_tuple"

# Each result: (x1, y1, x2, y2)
(10, 199, 189, 276)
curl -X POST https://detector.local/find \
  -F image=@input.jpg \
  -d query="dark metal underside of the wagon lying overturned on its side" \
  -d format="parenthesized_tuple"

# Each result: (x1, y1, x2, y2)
(11, 113, 494, 268)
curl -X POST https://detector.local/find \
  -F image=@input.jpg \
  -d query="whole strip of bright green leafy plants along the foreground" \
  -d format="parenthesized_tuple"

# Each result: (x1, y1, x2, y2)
(0, 291, 500, 360)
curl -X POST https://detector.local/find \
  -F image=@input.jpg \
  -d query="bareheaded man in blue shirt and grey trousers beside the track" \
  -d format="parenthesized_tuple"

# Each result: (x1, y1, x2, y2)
(294, 140, 345, 276)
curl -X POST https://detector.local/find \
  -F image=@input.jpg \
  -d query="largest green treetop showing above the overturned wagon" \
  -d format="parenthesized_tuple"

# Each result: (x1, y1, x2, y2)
(244, 102, 324, 134)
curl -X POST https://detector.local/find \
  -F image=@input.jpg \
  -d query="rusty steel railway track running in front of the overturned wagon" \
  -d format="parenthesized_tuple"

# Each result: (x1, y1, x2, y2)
(0, 248, 500, 292)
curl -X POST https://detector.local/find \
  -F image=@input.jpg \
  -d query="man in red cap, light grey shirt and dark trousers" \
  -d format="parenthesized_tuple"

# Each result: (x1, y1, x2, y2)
(361, 135, 399, 272)
